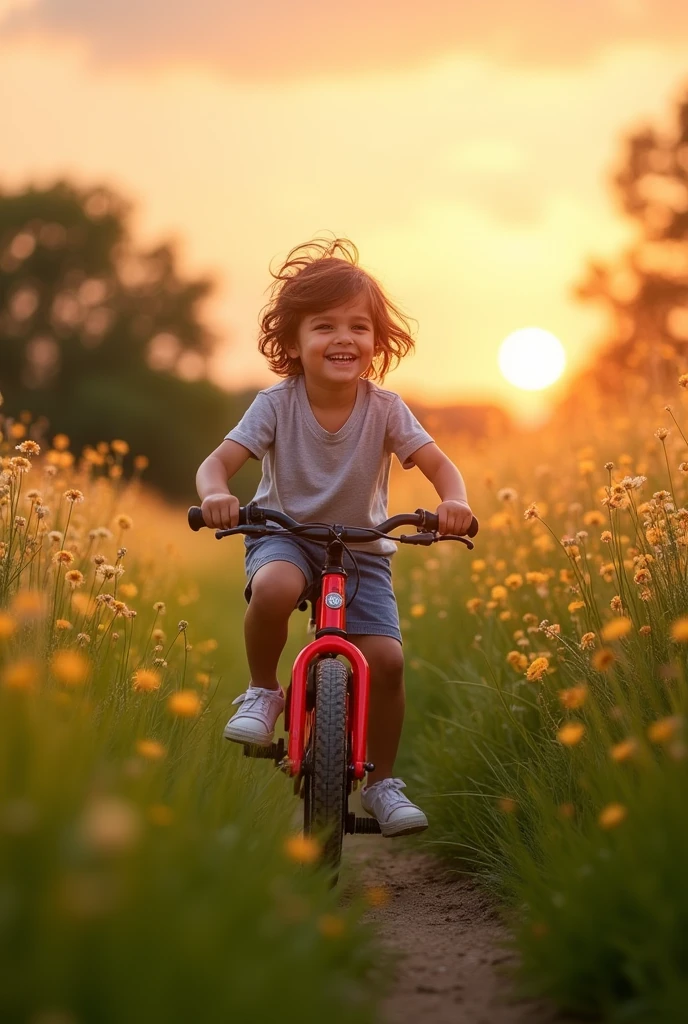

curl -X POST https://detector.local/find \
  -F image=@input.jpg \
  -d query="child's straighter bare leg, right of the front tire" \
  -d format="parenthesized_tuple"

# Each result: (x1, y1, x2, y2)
(349, 635, 405, 786)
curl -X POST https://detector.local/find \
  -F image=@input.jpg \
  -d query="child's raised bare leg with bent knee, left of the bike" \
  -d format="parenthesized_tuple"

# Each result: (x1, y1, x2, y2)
(244, 561, 306, 690)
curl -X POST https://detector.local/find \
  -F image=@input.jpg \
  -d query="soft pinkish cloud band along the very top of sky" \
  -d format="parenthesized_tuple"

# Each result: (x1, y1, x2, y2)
(0, 0, 688, 81)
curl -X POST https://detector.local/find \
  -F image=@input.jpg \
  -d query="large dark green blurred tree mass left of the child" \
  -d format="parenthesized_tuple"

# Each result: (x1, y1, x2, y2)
(0, 181, 261, 500)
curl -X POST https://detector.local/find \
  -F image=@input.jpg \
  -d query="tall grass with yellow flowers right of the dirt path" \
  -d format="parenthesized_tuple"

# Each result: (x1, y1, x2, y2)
(401, 387, 688, 1024)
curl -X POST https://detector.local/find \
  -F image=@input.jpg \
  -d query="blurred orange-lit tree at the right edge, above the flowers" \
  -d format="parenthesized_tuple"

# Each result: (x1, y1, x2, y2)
(576, 84, 688, 395)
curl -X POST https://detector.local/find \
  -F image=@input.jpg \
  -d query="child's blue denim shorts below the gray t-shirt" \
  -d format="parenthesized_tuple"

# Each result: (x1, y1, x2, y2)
(244, 534, 401, 643)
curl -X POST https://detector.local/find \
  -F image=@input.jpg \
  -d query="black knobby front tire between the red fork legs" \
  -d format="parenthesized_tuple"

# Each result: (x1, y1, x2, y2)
(304, 657, 349, 871)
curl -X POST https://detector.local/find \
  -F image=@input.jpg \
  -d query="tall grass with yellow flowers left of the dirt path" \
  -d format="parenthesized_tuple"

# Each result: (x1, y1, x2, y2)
(0, 415, 376, 1024)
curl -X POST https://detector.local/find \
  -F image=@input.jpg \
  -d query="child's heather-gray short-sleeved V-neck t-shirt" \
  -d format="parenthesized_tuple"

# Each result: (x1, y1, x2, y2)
(225, 374, 433, 554)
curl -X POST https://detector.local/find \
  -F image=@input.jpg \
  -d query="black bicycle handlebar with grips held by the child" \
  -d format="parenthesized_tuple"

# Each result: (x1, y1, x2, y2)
(188, 503, 479, 549)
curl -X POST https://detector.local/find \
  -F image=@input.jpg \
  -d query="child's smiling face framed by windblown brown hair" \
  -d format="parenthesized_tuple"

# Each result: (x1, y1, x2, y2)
(287, 295, 375, 387)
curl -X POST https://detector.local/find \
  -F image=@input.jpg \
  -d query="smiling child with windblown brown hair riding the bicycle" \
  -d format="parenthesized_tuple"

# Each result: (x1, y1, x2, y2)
(197, 239, 472, 837)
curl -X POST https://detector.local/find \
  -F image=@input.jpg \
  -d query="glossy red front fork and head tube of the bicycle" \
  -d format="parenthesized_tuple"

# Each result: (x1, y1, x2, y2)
(285, 567, 371, 779)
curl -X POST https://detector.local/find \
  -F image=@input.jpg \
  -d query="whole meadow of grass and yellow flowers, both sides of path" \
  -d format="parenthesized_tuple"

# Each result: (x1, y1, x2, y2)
(0, 384, 688, 1024)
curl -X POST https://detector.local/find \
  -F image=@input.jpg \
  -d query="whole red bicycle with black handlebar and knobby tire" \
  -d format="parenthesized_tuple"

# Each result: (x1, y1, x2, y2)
(188, 503, 478, 881)
